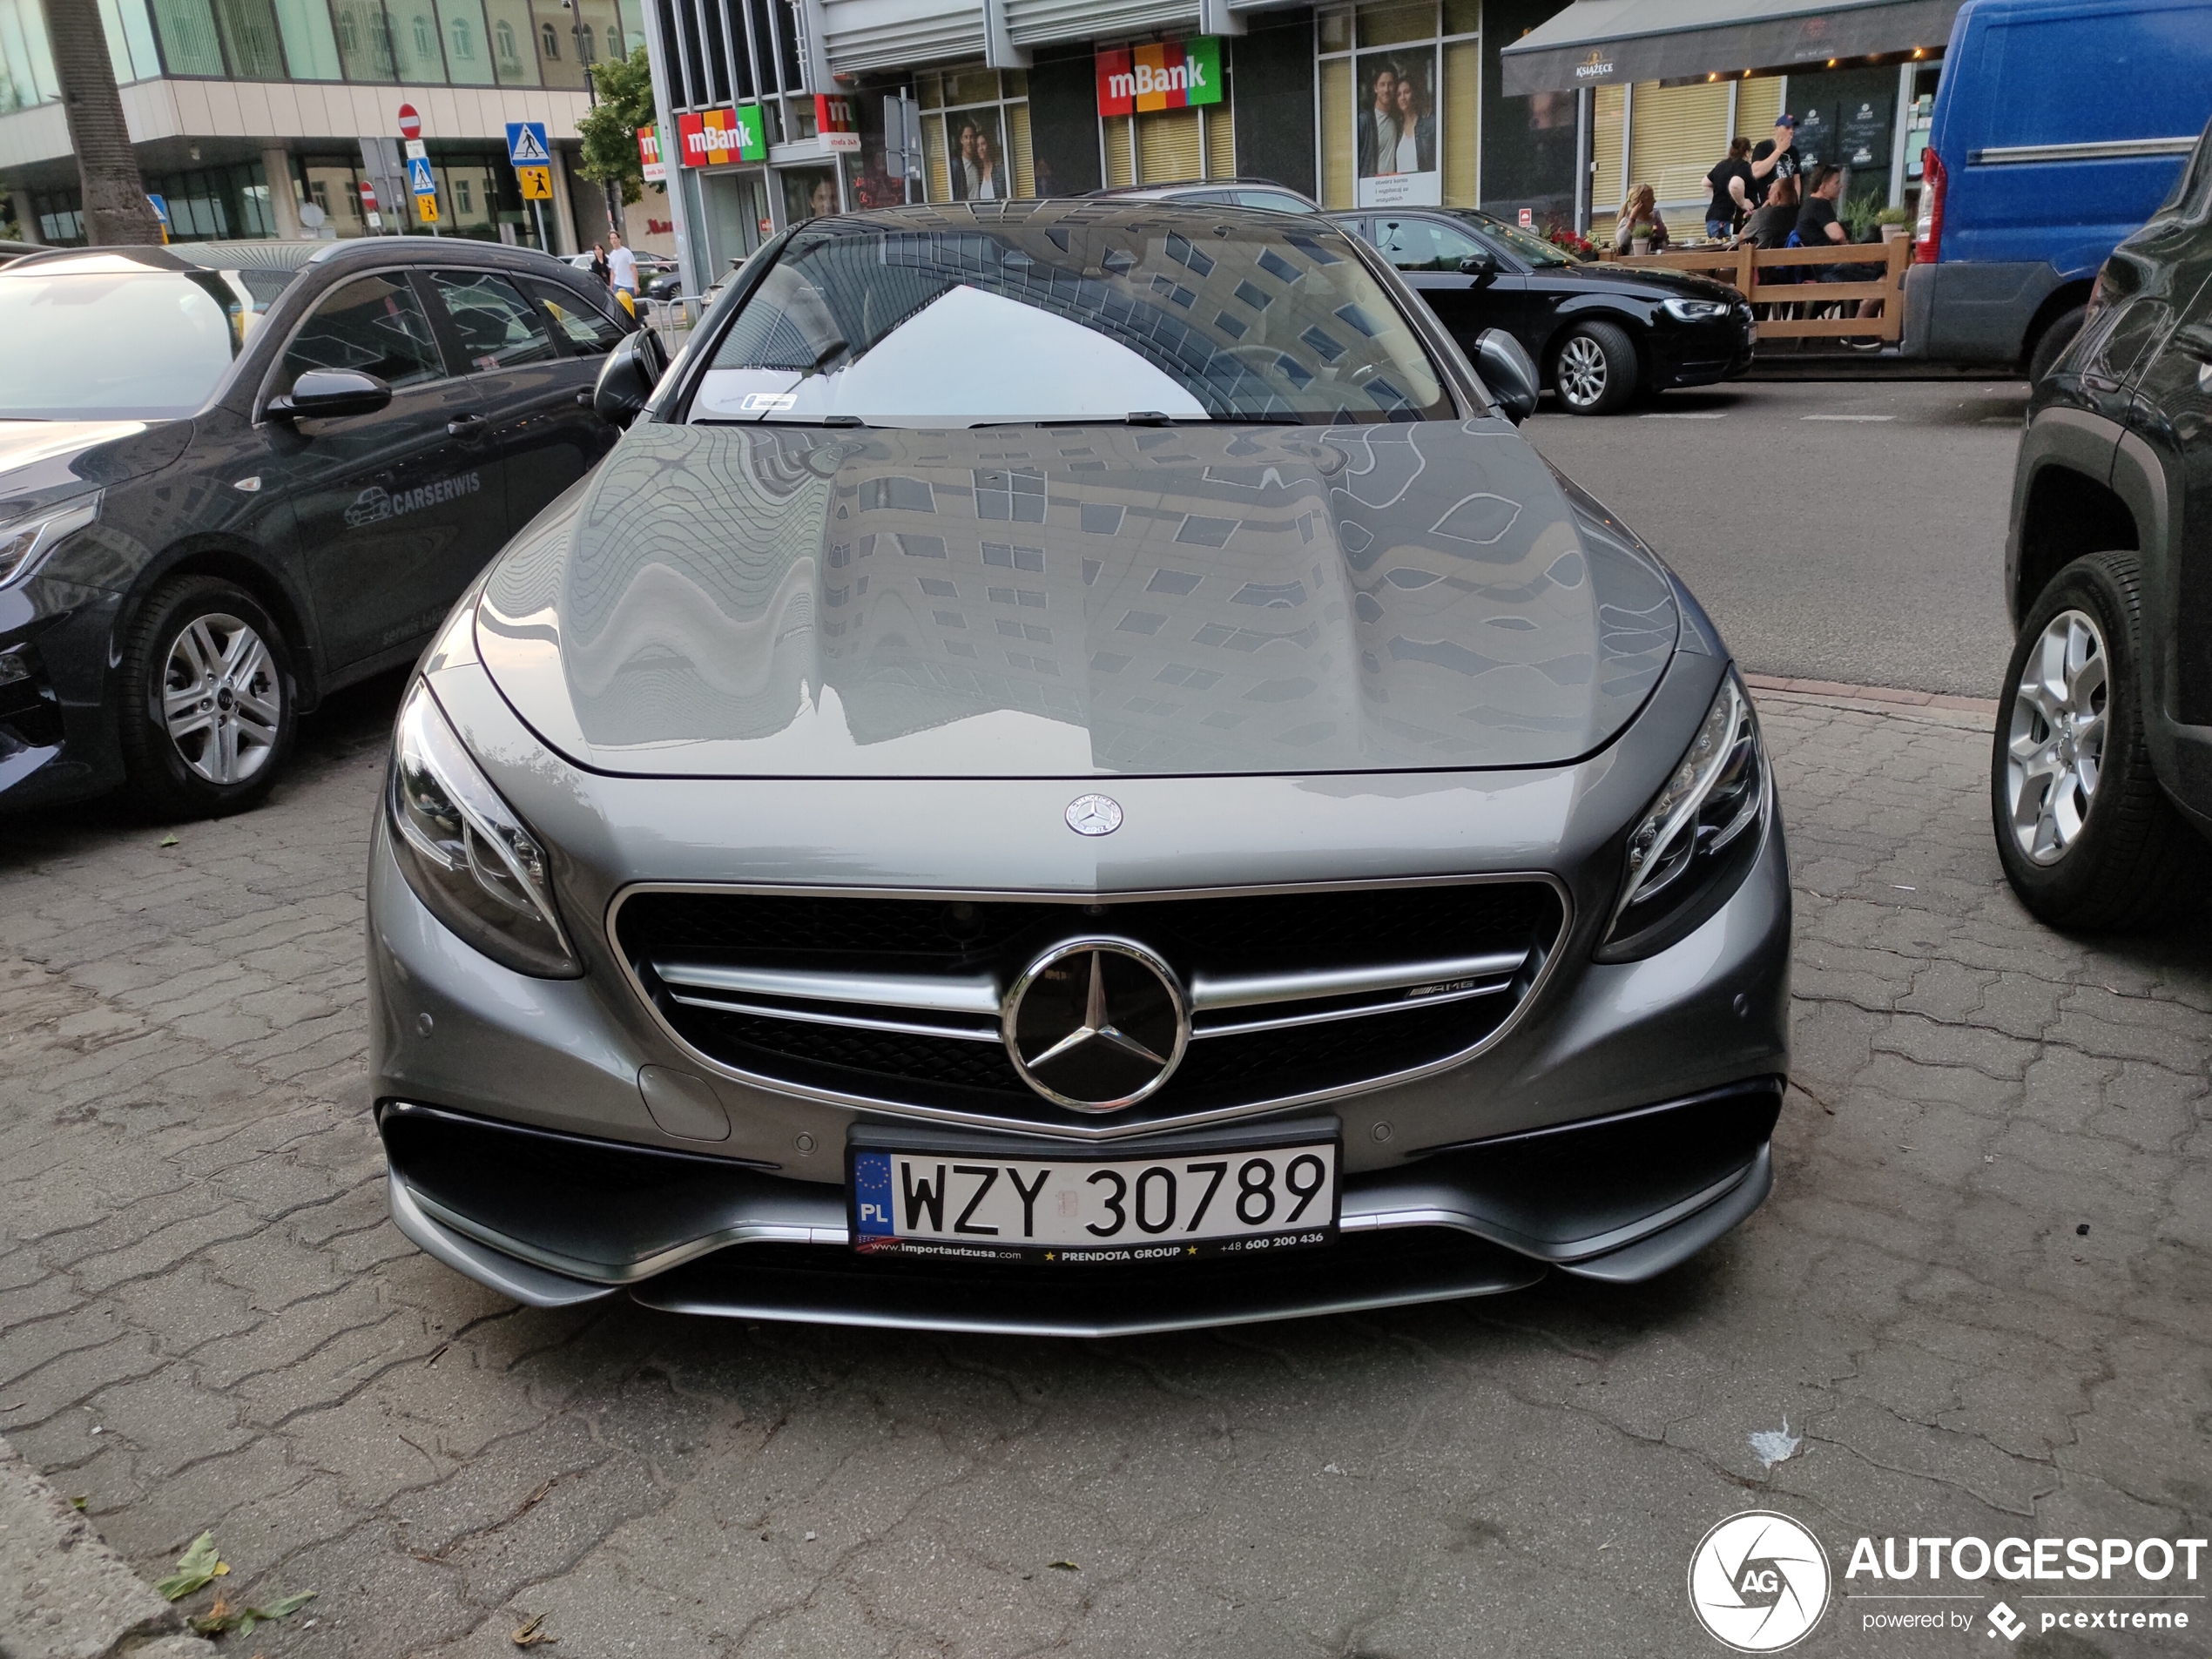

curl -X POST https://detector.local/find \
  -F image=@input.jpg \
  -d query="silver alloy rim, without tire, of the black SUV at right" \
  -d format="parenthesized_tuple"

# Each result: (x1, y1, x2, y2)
(2004, 610, 2110, 865)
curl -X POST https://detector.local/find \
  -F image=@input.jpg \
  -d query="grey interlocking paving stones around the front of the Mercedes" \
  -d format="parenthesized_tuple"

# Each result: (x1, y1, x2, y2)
(0, 681, 2212, 1659)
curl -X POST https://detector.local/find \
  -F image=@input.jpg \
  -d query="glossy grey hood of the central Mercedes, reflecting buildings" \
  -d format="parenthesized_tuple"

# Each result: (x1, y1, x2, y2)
(475, 421, 1681, 777)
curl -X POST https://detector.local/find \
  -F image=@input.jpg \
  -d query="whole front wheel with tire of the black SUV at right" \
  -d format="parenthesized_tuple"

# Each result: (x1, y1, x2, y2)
(1988, 553, 2205, 931)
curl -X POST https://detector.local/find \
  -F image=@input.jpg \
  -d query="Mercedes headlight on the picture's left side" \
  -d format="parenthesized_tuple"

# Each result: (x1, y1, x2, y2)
(385, 679, 584, 980)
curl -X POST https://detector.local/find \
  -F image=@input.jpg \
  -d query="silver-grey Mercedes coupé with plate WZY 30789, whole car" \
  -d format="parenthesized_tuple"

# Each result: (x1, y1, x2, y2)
(369, 201, 1790, 1334)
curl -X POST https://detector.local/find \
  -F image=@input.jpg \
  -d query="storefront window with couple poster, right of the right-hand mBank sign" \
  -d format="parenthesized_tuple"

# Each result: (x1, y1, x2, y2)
(1316, 0, 1482, 208)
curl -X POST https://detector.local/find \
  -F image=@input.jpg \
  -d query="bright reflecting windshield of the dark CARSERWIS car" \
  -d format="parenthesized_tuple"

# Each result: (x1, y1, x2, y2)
(0, 267, 254, 421)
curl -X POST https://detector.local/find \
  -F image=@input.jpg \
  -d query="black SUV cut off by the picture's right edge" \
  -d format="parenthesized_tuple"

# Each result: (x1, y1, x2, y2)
(1991, 117, 2212, 929)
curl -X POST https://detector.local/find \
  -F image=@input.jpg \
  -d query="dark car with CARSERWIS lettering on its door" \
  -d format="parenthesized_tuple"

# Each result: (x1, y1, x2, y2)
(0, 237, 635, 814)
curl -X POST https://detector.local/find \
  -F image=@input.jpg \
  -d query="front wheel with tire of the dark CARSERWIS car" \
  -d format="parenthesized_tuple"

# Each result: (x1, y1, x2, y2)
(122, 575, 299, 819)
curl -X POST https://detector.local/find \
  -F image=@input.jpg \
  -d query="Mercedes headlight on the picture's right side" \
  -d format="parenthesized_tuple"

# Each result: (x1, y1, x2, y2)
(1597, 668, 1774, 962)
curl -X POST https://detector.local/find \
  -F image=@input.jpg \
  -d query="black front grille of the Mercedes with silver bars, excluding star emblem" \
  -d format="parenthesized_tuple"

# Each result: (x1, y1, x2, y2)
(615, 880, 1564, 1123)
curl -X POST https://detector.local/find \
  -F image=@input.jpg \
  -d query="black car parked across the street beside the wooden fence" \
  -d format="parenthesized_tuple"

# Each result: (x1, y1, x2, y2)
(1330, 208, 1752, 414)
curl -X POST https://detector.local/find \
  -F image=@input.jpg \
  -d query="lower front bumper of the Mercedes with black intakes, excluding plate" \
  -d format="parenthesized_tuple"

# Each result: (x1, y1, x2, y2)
(378, 1077, 1783, 1336)
